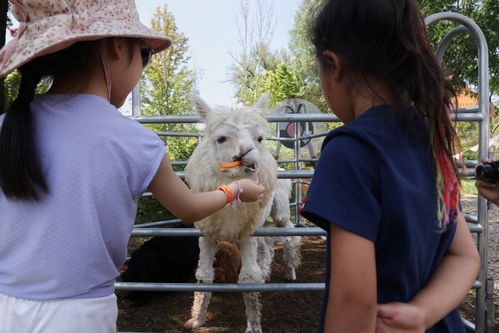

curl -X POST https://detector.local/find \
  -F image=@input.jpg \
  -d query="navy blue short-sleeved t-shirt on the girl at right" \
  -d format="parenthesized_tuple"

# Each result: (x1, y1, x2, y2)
(302, 105, 465, 333)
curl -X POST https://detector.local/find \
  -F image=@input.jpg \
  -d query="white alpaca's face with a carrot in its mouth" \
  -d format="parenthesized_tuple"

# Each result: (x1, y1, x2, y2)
(192, 94, 268, 178)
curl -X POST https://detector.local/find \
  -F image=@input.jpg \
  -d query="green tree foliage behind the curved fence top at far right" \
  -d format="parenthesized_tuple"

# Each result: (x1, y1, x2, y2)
(418, 0, 499, 160)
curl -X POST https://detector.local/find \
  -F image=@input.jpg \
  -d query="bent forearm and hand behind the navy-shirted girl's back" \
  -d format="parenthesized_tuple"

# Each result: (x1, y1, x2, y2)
(377, 212, 480, 333)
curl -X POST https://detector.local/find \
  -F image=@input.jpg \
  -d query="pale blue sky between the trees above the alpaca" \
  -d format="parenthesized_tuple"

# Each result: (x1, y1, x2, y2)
(135, 0, 301, 105)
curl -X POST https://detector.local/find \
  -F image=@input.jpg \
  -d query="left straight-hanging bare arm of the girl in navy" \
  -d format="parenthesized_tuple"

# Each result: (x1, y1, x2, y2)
(324, 224, 377, 333)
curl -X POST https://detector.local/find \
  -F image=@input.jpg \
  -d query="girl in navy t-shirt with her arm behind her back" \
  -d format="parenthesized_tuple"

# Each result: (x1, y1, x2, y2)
(303, 0, 479, 333)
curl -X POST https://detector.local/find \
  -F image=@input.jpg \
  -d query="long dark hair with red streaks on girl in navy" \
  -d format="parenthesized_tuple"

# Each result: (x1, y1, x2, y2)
(310, 0, 459, 222)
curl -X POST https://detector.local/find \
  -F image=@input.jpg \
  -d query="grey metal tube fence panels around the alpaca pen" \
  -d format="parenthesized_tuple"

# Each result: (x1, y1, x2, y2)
(116, 12, 494, 333)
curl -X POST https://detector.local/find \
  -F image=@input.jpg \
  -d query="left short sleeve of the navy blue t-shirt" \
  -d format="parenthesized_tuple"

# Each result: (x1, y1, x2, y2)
(302, 135, 381, 242)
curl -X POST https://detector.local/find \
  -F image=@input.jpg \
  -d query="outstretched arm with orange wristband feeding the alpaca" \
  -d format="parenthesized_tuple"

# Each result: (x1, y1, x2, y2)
(149, 155, 265, 222)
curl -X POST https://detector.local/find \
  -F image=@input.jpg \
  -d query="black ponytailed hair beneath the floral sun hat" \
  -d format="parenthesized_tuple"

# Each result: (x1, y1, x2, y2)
(0, 42, 100, 200)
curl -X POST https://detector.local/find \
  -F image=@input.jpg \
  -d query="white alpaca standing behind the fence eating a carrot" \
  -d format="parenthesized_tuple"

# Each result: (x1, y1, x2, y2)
(185, 95, 301, 333)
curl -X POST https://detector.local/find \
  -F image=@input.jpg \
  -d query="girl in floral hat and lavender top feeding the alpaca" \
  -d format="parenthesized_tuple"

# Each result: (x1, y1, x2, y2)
(0, 0, 264, 333)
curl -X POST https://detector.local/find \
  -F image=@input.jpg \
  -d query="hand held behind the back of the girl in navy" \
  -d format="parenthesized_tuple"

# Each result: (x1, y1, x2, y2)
(376, 303, 425, 333)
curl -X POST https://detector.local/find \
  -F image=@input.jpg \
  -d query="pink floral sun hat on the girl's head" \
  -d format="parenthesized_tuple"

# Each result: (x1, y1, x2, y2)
(0, 0, 171, 77)
